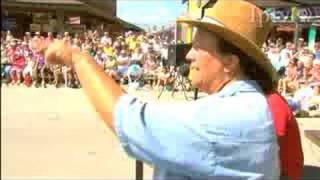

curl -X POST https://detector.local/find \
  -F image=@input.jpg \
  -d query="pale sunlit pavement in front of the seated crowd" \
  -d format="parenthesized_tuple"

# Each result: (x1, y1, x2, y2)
(1, 86, 320, 180)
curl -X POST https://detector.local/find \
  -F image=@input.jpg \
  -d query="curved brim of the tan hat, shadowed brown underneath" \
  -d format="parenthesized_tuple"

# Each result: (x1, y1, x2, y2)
(177, 18, 278, 81)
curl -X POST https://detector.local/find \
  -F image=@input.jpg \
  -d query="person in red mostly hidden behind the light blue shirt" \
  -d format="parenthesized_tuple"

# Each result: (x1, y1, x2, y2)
(267, 92, 303, 180)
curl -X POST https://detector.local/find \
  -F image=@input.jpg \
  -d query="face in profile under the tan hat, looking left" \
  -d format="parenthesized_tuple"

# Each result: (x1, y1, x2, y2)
(186, 29, 228, 92)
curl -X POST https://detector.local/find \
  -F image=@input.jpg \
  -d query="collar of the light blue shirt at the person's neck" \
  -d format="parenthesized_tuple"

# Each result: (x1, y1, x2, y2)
(217, 80, 262, 97)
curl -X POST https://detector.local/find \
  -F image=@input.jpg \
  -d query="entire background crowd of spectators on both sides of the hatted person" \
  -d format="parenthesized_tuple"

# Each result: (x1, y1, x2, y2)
(1, 31, 320, 116)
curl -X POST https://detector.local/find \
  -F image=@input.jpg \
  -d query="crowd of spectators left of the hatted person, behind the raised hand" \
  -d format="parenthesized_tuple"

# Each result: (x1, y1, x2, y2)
(1, 31, 180, 88)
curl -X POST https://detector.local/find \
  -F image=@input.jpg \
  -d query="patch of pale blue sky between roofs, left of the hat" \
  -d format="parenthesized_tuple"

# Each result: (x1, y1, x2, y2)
(117, 0, 187, 26)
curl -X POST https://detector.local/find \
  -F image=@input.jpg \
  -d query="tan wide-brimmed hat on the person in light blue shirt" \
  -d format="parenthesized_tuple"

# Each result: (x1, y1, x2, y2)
(177, 0, 277, 80)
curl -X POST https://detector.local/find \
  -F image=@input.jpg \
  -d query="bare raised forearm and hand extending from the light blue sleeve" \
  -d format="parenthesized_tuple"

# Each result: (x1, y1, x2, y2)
(32, 40, 124, 132)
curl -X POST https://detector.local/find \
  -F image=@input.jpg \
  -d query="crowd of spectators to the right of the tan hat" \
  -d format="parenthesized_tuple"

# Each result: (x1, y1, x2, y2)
(263, 38, 320, 115)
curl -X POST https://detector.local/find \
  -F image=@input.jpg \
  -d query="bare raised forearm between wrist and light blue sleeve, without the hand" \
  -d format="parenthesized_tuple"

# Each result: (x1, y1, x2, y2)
(72, 51, 124, 133)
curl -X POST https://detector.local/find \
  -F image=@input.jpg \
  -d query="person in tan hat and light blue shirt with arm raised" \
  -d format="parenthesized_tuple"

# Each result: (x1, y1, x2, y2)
(31, 0, 279, 180)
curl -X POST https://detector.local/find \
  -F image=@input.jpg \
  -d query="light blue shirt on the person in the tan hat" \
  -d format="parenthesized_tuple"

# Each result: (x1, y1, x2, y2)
(114, 81, 279, 180)
